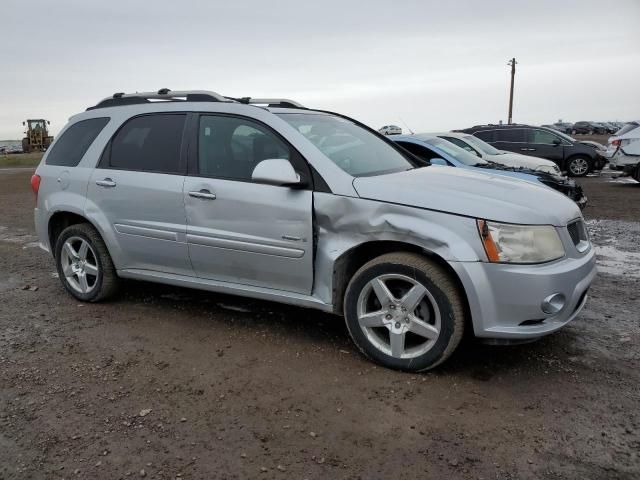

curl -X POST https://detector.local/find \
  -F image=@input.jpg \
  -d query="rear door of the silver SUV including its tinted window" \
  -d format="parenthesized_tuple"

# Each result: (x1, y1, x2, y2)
(86, 114, 193, 276)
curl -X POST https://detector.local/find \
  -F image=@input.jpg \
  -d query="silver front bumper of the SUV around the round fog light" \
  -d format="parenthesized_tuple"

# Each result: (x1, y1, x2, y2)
(451, 246, 596, 340)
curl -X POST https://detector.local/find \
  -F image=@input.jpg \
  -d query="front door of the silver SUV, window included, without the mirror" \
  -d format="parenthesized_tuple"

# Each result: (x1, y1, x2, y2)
(184, 114, 313, 294)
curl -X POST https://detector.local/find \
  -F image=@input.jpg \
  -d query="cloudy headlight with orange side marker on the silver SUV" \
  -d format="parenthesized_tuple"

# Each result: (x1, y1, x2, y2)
(477, 220, 564, 263)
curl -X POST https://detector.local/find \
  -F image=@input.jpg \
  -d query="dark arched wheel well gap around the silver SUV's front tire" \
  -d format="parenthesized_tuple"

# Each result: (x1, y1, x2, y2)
(332, 241, 473, 322)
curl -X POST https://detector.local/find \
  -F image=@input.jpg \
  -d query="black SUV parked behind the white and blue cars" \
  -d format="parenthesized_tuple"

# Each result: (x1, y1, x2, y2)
(458, 124, 606, 177)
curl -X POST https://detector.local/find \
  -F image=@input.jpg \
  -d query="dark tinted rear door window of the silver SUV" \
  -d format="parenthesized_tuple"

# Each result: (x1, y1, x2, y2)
(108, 114, 186, 175)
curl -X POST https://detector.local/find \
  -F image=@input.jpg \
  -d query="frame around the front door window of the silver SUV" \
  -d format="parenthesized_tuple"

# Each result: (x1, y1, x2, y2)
(187, 112, 318, 190)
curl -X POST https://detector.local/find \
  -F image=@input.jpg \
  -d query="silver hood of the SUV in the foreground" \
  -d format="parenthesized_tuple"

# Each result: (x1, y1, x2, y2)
(353, 166, 581, 226)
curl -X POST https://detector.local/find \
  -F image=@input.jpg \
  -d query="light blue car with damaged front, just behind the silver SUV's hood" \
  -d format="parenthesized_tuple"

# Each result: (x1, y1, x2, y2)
(389, 134, 587, 209)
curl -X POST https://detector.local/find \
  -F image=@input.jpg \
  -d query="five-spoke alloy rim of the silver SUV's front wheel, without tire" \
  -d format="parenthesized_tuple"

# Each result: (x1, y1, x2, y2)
(357, 274, 441, 359)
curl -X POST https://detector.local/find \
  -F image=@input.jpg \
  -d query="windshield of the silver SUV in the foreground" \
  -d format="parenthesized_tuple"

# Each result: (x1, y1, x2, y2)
(278, 113, 415, 177)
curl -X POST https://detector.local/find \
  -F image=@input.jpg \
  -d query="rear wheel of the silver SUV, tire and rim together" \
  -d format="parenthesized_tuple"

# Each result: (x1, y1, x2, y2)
(55, 223, 118, 302)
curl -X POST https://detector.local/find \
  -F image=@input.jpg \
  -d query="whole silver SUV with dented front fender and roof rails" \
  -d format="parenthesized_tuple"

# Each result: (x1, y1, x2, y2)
(32, 89, 596, 371)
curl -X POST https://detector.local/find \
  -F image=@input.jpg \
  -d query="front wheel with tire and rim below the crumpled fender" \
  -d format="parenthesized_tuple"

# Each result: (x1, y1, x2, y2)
(344, 253, 465, 372)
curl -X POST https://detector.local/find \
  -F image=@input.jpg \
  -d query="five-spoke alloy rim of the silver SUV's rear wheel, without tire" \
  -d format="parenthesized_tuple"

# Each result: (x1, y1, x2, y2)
(60, 237, 99, 294)
